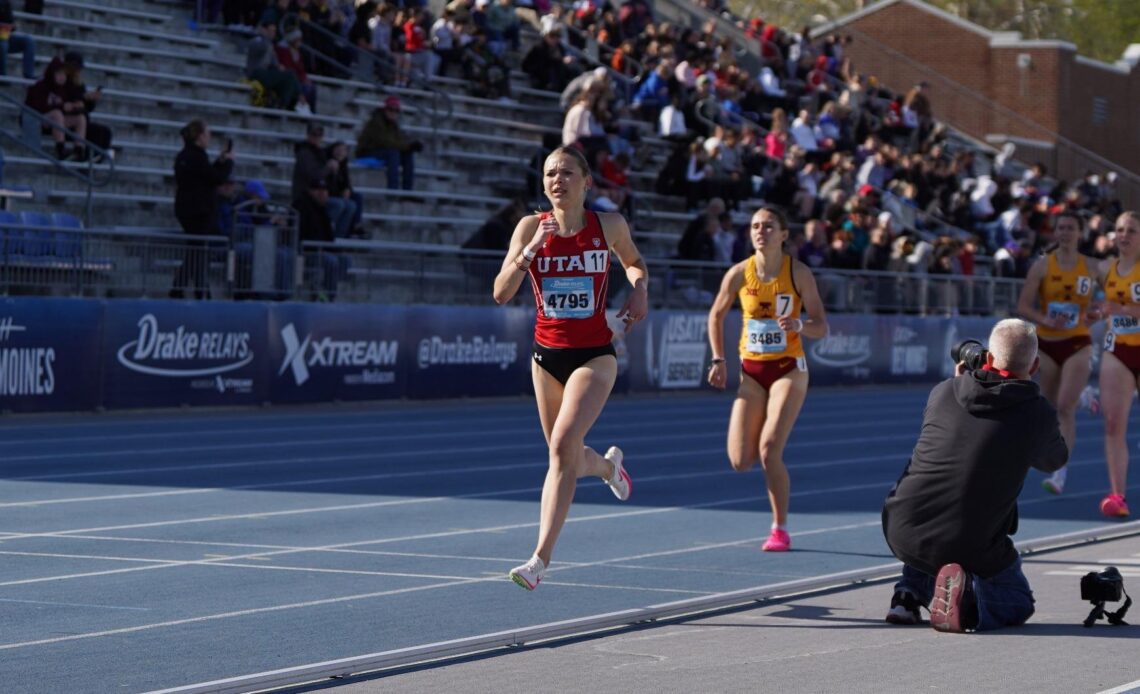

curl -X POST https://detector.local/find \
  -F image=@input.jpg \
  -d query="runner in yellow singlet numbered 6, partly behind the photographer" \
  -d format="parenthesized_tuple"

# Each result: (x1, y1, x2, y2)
(1017, 212, 1100, 493)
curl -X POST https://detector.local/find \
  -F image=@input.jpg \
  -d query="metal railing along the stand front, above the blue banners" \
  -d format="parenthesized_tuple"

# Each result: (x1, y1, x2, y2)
(0, 224, 1021, 316)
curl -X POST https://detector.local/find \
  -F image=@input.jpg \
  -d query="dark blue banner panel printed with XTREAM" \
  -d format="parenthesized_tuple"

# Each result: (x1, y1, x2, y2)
(268, 303, 413, 402)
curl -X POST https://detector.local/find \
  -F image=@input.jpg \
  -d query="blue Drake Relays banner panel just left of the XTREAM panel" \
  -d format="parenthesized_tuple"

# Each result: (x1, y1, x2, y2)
(97, 300, 269, 408)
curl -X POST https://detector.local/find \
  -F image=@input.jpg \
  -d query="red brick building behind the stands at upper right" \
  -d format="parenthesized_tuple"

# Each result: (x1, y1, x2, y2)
(816, 0, 1140, 206)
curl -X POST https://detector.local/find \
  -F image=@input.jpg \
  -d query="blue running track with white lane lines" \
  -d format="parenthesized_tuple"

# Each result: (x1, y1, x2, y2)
(0, 387, 1140, 693)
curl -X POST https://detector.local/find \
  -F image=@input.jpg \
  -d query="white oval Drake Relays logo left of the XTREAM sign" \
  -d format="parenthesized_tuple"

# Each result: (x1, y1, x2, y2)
(119, 313, 253, 378)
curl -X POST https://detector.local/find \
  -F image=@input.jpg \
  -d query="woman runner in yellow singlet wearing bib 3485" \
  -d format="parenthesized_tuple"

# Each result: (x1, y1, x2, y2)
(708, 207, 828, 552)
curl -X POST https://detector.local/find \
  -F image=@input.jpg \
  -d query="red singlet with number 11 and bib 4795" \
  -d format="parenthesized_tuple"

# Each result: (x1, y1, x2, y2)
(528, 211, 613, 349)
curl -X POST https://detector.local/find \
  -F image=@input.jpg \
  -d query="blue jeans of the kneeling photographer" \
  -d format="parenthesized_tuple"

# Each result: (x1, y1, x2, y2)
(895, 558, 1034, 631)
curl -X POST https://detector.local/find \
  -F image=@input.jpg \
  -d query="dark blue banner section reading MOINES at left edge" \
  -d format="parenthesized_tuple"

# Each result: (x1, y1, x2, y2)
(0, 299, 103, 413)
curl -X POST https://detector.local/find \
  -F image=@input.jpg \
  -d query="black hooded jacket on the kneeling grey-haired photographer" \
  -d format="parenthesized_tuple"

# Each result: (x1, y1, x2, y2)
(882, 370, 1068, 578)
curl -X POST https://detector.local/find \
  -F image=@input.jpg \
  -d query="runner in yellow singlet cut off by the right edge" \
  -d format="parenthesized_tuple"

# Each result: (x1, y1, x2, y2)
(1100, 211, 1140, 517)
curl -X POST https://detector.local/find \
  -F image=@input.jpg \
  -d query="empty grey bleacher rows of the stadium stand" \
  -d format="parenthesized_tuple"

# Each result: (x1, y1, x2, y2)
(0, 0, 1121, 309)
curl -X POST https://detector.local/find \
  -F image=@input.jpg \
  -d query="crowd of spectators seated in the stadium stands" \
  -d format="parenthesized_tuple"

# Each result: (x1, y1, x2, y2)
(8, 0, 1121, 305)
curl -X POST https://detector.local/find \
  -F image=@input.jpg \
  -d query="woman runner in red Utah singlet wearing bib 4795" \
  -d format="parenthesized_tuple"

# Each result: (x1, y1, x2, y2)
(495, 147, 649, 590)
